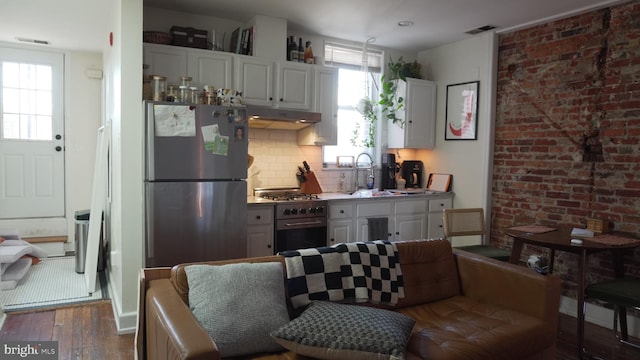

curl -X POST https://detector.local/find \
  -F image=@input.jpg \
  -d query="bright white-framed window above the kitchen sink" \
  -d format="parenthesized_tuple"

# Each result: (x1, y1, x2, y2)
(323, 42, 383, 165)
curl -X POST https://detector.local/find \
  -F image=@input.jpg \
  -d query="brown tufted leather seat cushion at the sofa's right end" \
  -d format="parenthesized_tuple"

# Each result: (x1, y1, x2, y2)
(399, 296, 555, 360)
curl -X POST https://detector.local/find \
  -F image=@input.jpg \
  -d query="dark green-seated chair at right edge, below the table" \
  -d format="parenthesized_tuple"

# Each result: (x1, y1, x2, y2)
(585, 277, 640, 349)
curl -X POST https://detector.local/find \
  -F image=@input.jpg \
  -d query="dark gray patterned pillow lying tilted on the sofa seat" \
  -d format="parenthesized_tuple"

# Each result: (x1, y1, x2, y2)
(271, 301, 415, 360)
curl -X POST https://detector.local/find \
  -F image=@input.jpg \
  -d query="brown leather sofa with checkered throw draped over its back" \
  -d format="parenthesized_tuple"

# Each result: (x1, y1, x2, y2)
(136, 240, 560, 360)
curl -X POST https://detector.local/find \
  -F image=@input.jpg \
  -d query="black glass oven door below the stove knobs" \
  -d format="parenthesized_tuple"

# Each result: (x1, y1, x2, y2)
(274, 217, 327, 254)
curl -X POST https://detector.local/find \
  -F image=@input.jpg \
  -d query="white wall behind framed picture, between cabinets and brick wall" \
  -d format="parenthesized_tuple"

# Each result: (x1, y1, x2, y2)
(417, 33, 497, 245)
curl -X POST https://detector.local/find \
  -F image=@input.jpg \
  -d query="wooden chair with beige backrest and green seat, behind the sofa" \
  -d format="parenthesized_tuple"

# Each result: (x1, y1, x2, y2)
(443, 208, 511, 261)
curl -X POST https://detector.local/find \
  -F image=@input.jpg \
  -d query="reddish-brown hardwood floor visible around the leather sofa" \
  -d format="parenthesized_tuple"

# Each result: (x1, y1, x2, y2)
(0, 300, 640, 360)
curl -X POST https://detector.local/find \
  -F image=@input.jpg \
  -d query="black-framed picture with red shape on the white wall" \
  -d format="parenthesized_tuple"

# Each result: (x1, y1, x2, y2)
(444, 81, 480, 140)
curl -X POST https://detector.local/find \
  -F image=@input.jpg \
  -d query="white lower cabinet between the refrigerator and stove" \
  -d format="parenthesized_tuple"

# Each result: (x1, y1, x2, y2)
(247, 205, 274, 257)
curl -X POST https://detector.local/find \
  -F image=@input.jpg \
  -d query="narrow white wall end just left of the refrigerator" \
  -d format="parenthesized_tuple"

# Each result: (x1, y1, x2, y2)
(104, 0, 143, 332)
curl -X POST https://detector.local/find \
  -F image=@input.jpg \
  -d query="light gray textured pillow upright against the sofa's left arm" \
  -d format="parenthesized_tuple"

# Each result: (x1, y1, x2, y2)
(185, 262, 289, 357)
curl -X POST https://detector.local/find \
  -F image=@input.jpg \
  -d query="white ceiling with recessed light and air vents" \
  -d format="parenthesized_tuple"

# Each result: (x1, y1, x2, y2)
(0, 0, 628, 52)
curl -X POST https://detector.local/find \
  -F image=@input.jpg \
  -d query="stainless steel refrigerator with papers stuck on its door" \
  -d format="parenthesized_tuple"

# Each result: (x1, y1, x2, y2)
(144, 102, 248, 267)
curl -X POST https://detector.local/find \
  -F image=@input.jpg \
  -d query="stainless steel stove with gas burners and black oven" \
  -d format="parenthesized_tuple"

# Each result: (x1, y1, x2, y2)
(253, 188, 327, 253)
